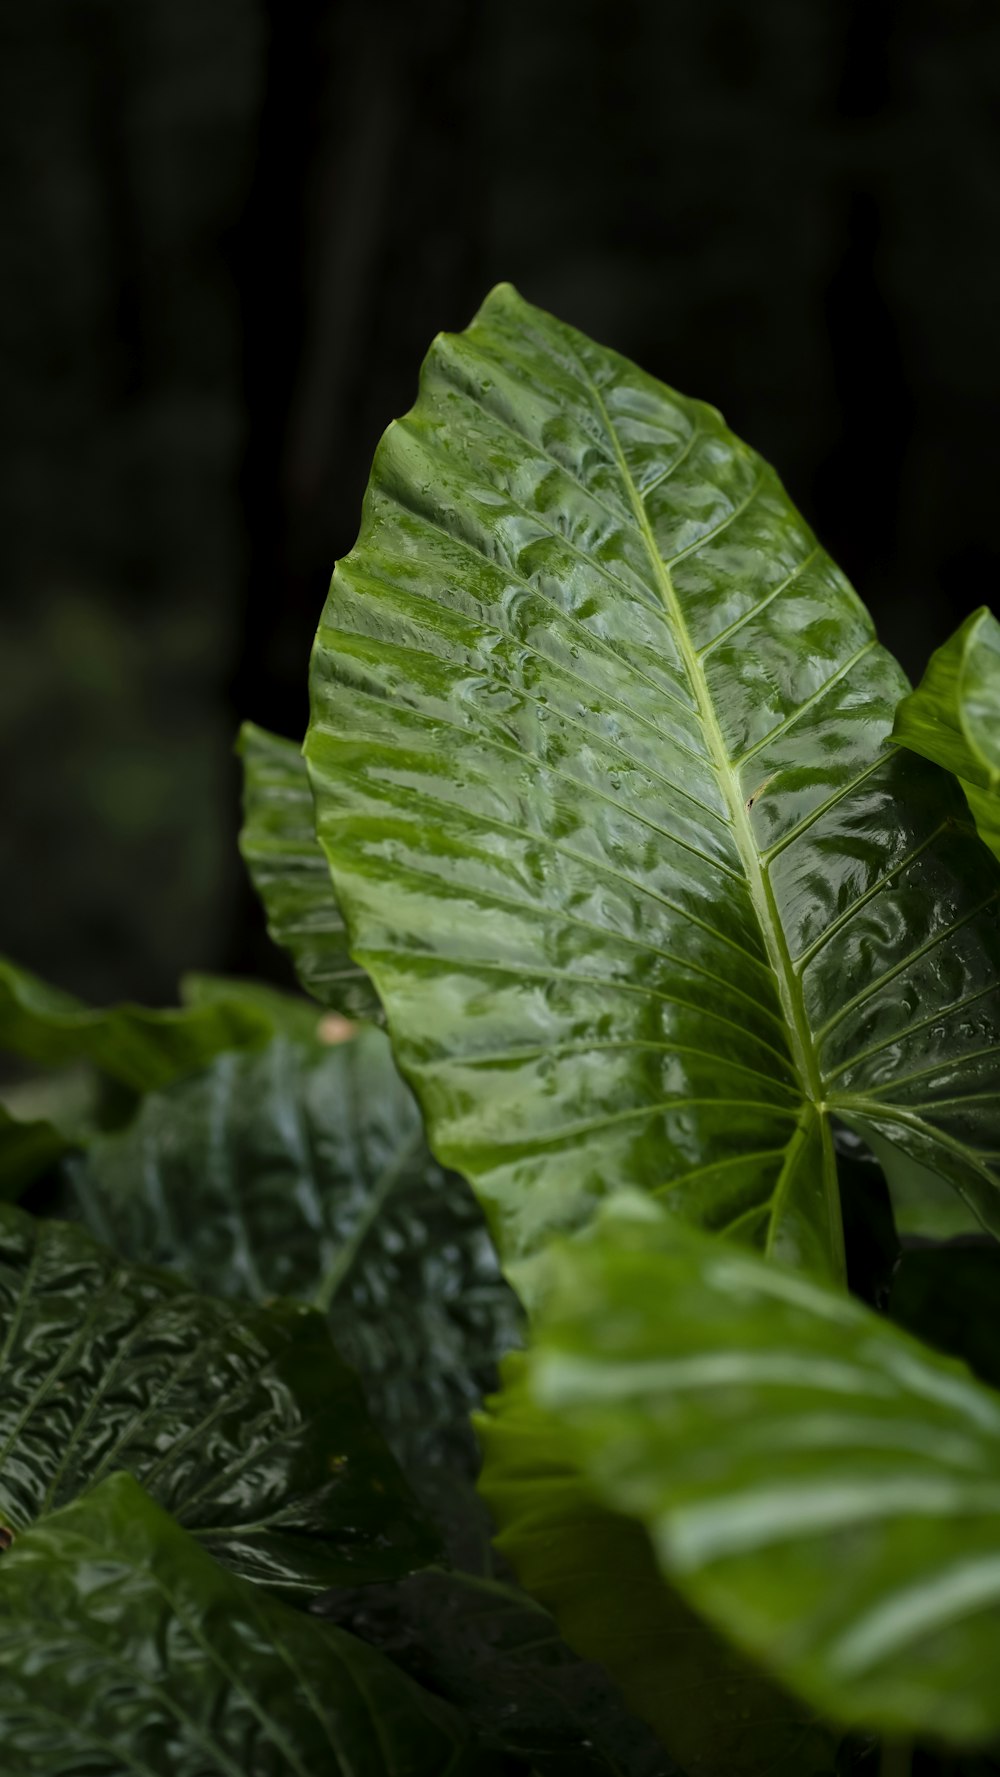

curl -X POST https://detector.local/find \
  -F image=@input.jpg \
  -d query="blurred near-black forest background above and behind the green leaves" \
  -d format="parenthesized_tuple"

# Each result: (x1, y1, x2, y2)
(0, 0, 1000, 1000)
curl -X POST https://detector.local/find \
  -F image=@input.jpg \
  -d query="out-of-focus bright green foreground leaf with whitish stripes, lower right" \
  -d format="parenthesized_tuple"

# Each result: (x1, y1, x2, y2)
(485, 1217, 1000, 1745)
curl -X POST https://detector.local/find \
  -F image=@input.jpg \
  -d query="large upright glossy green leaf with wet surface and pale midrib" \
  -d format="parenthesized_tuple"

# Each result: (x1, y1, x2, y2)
(306, 286, 1000, 1288)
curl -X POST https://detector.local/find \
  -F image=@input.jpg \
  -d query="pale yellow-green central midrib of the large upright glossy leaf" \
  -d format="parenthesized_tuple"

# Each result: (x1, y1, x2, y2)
(577, 359, 845, 1278)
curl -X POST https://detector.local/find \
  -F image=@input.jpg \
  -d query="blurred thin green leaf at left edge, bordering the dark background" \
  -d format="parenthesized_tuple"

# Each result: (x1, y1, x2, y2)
(0, 958, 272, 1093)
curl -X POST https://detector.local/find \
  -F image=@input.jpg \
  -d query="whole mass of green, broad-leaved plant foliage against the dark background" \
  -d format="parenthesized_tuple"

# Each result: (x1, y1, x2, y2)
(0, 288, 1000, 1777)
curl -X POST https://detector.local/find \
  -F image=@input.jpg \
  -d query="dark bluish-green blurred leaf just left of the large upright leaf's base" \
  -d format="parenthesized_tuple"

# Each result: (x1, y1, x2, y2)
(75, 1027, 519, 1549)
